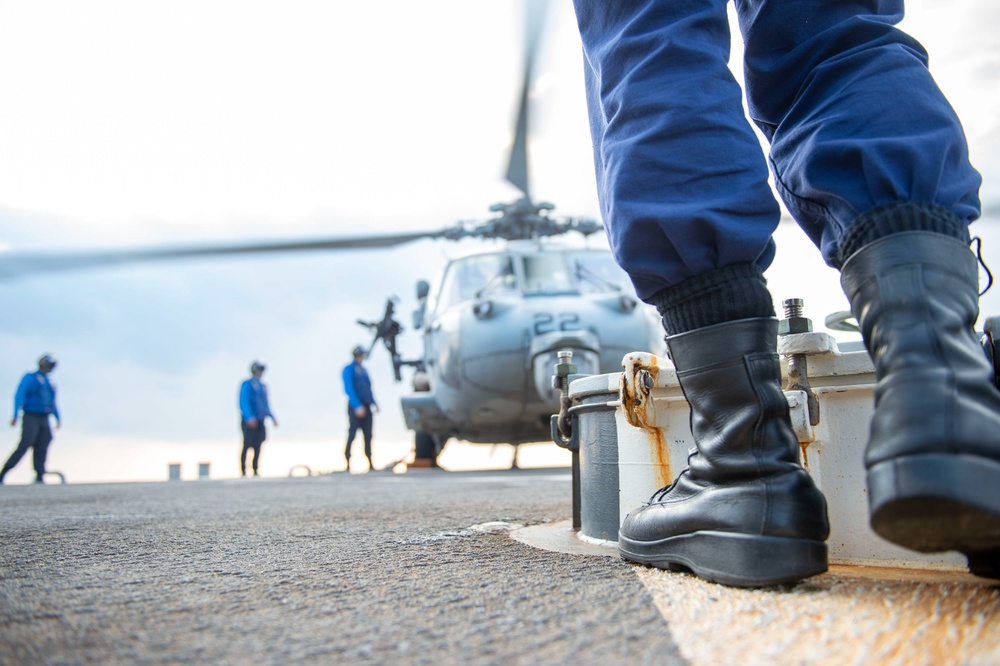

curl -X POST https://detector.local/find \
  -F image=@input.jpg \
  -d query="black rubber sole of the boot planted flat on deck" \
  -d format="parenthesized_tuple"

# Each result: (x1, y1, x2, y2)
(618, 531, 827, 587)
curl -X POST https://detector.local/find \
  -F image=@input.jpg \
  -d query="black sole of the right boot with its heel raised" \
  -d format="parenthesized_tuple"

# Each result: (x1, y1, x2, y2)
(868, 454, 1000, 578)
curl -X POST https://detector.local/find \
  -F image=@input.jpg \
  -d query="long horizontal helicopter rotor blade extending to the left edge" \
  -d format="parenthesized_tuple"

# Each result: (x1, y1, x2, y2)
(0, 231, 445, 280)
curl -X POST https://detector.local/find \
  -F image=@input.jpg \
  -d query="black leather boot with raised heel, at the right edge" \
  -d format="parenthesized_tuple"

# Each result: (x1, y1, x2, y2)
(841, 231, 1000, 578)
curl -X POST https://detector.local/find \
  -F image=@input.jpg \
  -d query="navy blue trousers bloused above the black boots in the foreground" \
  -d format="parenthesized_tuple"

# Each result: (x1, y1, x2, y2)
(575, 0, 981, 301)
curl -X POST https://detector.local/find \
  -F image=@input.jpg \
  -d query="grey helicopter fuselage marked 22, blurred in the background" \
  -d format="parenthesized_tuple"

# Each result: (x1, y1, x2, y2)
(402, 241, 663, 444)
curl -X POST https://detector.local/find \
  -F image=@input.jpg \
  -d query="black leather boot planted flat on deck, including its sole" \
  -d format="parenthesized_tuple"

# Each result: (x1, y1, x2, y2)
(618, 317, 830, 587)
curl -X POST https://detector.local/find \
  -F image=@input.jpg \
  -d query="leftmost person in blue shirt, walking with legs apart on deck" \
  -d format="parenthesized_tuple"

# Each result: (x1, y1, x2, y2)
(0, 354, 60, 483)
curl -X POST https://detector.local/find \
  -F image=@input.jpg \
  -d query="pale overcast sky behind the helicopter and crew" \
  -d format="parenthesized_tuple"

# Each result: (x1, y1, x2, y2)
(0, 0, 1000, 480)
